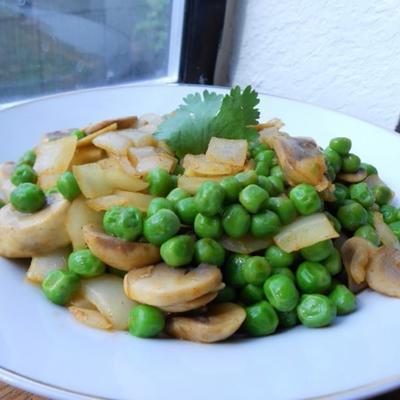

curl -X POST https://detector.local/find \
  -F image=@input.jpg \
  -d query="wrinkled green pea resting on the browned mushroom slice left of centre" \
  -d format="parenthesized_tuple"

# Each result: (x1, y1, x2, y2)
(103, 207, 143, 241)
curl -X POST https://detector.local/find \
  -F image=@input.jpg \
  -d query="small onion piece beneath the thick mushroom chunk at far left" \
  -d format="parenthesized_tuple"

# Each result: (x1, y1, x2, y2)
(26, 248, 70, 283)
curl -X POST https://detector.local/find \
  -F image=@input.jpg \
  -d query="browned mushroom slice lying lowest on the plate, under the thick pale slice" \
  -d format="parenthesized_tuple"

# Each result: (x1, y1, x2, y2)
(166, 303, 246, 343)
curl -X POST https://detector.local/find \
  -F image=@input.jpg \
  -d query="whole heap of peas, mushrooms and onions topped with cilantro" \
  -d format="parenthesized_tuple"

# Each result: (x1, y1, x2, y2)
(0, 87, 400, 343)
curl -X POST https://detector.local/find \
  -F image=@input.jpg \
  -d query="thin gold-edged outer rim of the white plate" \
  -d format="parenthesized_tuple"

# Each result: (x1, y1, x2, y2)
(0, 82, 400, 400)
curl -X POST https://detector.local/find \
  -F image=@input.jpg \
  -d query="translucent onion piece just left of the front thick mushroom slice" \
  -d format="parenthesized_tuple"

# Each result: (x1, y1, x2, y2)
(81, 274, 137, 330)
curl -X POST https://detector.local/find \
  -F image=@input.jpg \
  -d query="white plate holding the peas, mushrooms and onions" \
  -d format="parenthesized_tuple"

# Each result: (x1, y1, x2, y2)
(0, 86, 400, 400)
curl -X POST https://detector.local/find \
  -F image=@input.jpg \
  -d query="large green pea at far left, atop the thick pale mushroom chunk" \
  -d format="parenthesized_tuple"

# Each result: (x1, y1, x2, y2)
(10, 183, 46, 213)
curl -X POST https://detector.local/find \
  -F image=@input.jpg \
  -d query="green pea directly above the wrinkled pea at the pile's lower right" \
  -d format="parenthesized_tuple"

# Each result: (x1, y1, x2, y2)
(296, 261, 332, 293)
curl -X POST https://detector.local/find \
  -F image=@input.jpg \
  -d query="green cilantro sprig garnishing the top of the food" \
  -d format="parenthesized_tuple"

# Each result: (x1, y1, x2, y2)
(155, 86, 260, 158)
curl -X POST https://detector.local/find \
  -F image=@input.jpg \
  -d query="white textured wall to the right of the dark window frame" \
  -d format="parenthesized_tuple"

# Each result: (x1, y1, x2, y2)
(231, 0, 400, 129)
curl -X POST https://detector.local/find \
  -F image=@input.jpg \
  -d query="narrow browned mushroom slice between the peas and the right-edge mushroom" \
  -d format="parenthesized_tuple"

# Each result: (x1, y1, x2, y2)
(340, 237, 377, 293)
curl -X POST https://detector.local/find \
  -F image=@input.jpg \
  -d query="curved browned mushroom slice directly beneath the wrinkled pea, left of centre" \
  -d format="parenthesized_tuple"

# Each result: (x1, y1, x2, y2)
(83, 225, 161, 271)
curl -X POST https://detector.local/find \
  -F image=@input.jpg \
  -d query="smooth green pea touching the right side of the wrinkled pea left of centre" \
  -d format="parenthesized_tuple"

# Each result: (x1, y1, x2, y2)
(143, 209, 181, 246)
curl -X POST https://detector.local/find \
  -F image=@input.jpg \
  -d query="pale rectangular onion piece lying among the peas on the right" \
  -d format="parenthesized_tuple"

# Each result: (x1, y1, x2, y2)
(274, 213, 339, 253)
